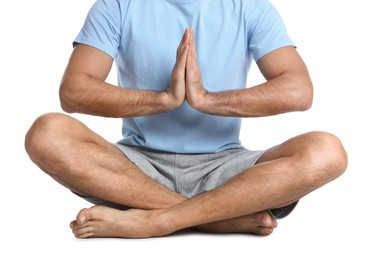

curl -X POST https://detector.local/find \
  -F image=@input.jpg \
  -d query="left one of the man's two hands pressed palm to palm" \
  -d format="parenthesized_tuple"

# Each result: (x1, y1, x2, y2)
(165, 29, 190, 109)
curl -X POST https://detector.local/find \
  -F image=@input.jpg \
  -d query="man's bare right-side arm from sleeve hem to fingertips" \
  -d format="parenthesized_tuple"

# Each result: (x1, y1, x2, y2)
(186, 41, 313, 117)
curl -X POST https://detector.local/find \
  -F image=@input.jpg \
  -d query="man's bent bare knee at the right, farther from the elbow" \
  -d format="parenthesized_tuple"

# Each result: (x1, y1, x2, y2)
(307, 132, 348, 180)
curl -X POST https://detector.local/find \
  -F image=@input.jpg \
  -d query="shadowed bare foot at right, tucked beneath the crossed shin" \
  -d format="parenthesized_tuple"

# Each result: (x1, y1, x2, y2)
(198, 211, 278, 236)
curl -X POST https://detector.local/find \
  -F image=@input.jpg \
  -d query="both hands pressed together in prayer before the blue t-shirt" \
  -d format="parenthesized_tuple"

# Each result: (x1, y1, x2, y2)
(166, 28, 208, 110)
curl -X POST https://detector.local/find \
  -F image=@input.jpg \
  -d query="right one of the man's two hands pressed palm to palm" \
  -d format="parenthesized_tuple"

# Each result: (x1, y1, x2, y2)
(186, 29, 208, 110)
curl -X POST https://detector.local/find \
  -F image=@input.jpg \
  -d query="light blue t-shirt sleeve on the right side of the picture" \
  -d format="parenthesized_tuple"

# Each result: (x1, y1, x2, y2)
(247, 0, 294, 61)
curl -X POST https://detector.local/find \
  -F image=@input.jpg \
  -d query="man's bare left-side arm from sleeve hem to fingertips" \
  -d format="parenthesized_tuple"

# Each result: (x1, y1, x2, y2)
(59, 39, 187, 117)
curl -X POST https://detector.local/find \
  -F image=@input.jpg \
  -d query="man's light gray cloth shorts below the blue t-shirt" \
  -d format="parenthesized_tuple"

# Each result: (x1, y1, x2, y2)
(77, 144, 294, 218)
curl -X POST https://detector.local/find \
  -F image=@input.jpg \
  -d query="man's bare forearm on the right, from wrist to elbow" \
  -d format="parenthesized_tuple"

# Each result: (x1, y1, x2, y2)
(196, 75, 312, 117)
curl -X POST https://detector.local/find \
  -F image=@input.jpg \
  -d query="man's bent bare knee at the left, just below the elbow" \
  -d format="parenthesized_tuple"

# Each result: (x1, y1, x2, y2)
(24, 113, 71, 159)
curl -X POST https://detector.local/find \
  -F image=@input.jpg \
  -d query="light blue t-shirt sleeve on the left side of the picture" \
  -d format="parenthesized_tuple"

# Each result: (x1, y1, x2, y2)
(73, 0, 121, 59)
